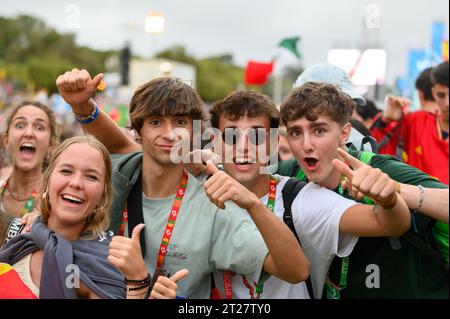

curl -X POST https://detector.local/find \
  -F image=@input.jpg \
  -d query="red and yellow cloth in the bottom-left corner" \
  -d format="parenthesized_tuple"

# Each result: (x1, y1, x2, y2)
(0, 263, 37, 299)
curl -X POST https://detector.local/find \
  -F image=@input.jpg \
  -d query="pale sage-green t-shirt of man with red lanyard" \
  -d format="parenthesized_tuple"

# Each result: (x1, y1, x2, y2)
(111, 155, 268, 299)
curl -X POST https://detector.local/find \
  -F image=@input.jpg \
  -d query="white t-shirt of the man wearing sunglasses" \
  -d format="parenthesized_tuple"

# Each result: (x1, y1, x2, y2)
(214, 175, 358, 299)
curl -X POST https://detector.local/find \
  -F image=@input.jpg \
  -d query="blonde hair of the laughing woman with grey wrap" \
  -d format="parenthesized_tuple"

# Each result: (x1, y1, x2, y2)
(39, 135, 113, 239)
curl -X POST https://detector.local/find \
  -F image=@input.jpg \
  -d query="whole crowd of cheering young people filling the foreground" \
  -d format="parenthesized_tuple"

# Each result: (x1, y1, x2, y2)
(0, 62, 449, 299)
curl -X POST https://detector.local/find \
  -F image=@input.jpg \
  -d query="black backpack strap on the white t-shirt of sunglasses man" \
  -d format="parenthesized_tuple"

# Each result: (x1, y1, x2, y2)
(281, 177, 314, 299)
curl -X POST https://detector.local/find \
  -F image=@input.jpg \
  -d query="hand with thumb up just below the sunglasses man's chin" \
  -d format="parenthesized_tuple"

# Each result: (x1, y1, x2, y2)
(203, 160, 259, 210)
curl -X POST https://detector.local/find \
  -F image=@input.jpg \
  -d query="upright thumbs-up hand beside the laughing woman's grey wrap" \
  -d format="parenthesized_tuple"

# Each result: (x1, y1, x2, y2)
(108, 224, 147, 280)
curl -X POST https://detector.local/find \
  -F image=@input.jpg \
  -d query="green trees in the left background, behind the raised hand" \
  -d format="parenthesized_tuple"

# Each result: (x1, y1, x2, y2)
(0, 15, 114, 92)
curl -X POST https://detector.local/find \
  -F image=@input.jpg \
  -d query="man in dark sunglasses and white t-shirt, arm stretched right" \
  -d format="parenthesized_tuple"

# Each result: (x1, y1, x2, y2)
(209, 90, 409, 299)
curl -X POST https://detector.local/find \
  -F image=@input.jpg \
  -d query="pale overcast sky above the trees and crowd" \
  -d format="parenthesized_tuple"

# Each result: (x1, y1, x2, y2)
(0, 0, 449, 84)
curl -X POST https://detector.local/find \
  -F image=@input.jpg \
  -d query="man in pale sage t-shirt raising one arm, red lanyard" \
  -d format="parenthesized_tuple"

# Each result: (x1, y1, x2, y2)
(57, 69, 309, 298)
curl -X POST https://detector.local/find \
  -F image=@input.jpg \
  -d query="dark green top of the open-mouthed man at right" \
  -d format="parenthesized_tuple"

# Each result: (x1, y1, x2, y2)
(272, 152, 449, 299)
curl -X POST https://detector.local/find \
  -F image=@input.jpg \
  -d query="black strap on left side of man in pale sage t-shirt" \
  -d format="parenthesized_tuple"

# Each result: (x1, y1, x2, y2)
(127, 171, 145, 257)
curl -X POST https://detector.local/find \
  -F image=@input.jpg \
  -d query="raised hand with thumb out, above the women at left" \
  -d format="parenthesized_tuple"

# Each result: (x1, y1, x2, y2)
(56, 69, 103, 107)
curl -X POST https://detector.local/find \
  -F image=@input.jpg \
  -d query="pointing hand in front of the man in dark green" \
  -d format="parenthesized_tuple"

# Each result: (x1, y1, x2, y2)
(333, 148, 397, 209)
